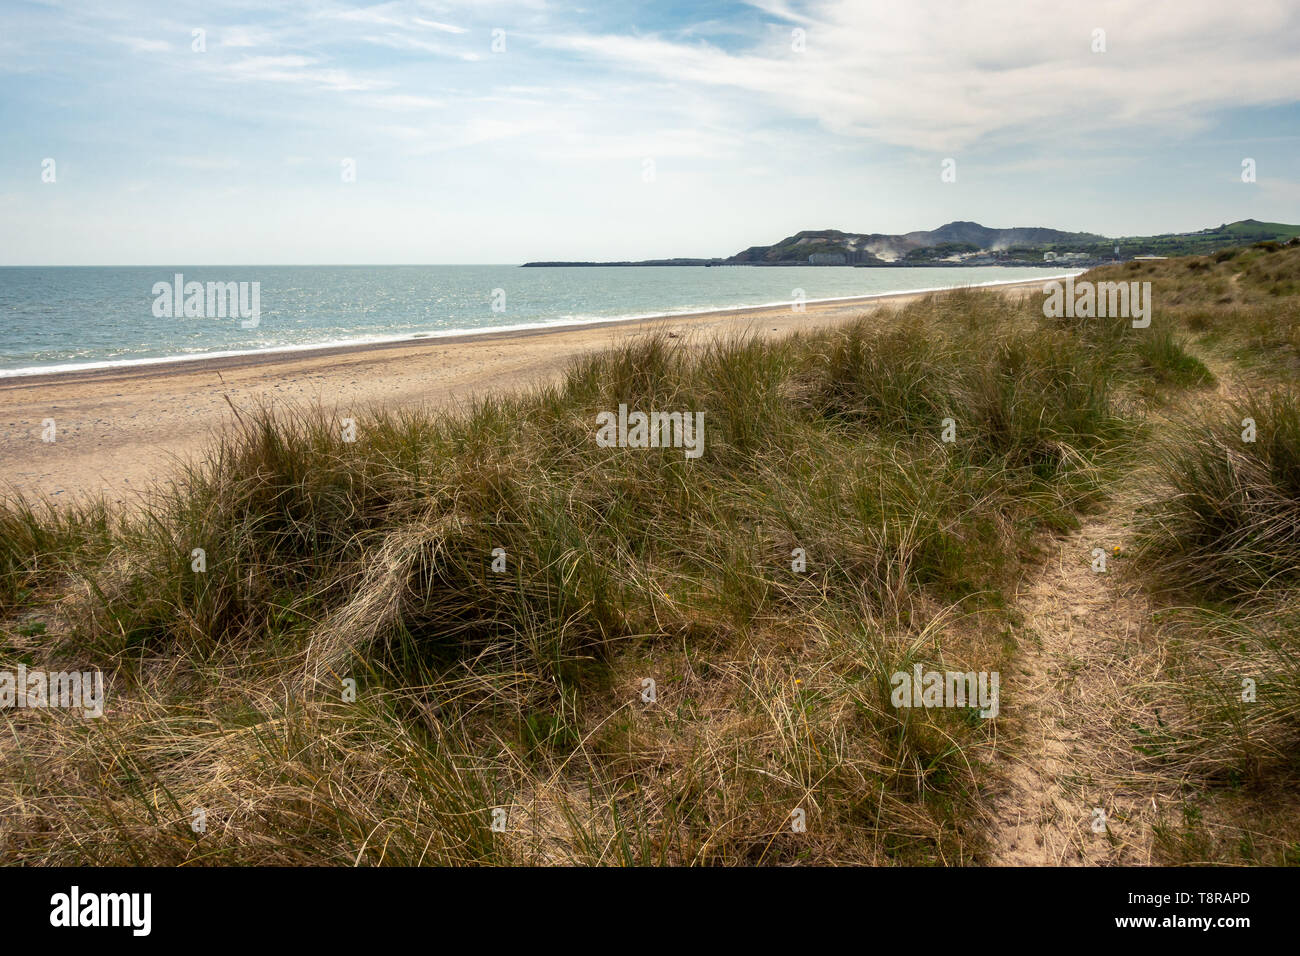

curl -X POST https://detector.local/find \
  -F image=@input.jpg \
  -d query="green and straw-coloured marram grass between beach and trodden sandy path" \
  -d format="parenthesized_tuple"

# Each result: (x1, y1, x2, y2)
(0, 251, 1294, 865)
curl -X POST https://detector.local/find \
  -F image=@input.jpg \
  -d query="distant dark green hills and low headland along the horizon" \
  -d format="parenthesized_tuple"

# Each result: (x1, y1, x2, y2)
(525, 219, 1300, 267)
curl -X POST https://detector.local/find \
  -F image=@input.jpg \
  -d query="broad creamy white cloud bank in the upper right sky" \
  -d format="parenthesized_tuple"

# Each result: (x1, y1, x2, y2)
(538, 0, 1300, 151)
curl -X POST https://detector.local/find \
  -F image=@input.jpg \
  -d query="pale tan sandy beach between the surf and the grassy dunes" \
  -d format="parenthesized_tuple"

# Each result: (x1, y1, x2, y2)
(0, 276, 1048, 503)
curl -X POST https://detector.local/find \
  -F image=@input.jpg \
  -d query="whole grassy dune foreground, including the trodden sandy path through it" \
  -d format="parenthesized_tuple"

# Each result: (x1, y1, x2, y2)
(0, 250, 1300, 865)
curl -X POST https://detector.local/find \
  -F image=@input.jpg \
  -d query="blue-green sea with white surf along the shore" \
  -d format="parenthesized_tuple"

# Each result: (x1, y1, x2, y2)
(0, 265, 1050, 377)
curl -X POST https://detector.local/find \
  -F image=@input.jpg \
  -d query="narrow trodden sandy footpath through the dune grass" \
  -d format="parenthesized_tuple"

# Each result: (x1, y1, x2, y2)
(987, 498, 1177, 866)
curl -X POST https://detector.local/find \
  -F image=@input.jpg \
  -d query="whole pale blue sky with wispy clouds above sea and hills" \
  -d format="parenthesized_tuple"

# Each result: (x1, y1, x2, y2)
(0, 0, 1300, 265)
